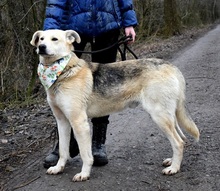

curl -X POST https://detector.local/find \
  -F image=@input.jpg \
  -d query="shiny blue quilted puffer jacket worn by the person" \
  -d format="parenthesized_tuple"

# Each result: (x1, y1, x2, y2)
(44, 0, 137, 37)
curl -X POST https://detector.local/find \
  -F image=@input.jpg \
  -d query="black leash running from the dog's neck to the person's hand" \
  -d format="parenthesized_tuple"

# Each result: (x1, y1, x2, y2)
(74, 36, 138, 61)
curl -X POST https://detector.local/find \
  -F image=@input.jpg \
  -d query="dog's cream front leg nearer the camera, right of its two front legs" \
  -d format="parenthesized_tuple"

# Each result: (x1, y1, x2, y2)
(70, 111, 93, 182)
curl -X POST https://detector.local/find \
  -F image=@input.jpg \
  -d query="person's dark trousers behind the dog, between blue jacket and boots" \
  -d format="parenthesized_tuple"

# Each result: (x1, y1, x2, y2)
(74, 30, 120, 126)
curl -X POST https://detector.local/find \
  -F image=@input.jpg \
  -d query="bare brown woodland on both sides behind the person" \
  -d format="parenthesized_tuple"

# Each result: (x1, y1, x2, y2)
(0, 0, 220, 109)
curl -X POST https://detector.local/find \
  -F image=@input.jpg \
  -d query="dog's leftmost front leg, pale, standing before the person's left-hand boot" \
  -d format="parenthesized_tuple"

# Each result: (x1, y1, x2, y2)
(47, 108, 71, 174)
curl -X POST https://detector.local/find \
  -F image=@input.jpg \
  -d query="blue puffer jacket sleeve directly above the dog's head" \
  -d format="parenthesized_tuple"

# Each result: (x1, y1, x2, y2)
(43, 0, 67, 30)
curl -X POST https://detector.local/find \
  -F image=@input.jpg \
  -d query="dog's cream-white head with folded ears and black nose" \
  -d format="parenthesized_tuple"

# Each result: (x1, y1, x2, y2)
(30, 29, 81, 60)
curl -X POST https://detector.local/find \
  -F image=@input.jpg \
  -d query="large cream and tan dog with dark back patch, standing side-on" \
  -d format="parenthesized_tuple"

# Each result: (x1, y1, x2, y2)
(30, 29, 200, 181)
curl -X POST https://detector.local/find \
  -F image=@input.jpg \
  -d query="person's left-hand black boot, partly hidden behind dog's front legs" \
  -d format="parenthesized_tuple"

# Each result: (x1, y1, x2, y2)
(44, 130, 79, 168)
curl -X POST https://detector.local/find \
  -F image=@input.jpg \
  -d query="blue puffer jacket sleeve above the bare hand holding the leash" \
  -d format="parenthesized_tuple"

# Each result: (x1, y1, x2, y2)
(118, 0, 138, 27)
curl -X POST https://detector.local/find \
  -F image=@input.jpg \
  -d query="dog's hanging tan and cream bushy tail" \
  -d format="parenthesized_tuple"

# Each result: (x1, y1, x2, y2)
(176, 74, 200, 141)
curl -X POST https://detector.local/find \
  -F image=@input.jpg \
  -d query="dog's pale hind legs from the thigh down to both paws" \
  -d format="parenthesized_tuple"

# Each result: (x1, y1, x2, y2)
(143, 99, 184, 175)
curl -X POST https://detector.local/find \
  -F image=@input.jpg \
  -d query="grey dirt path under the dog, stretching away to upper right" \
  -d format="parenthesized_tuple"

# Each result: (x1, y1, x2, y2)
(1, 26, 220, 191)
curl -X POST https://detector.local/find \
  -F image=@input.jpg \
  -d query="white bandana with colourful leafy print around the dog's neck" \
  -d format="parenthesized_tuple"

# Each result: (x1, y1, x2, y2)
(37, 54, 71, 89)
